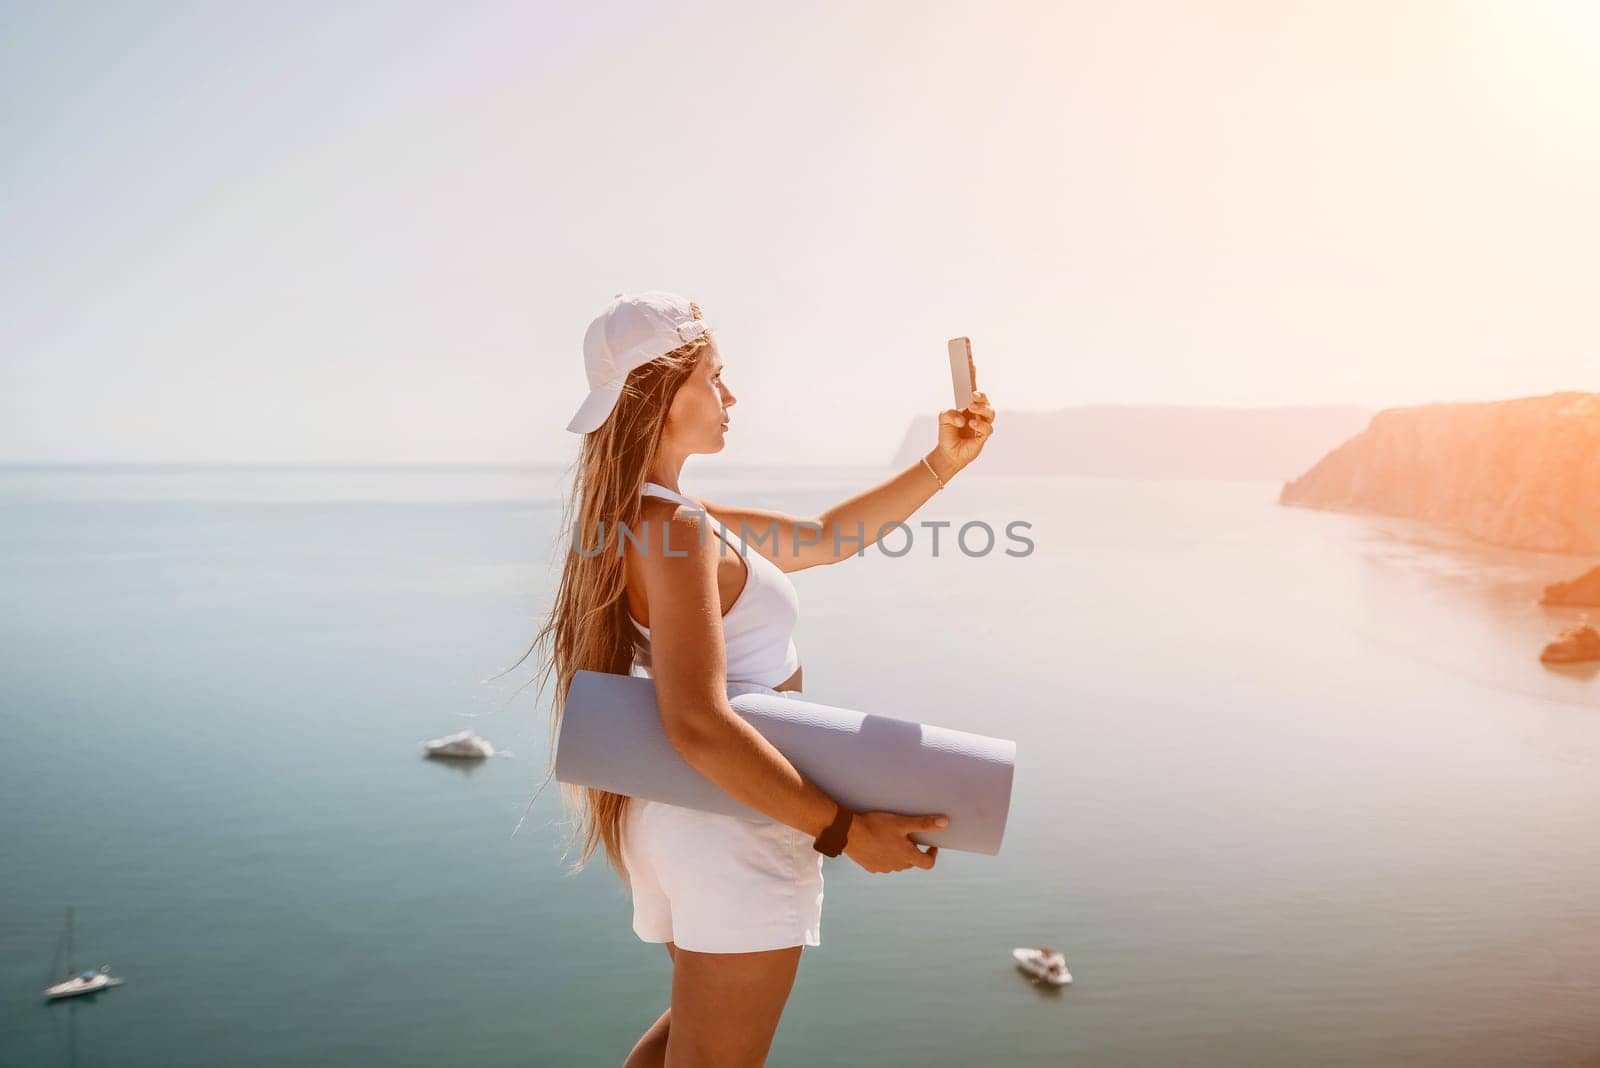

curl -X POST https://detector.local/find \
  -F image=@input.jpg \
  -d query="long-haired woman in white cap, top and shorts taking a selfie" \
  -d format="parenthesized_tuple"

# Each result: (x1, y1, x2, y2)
(536, 291, 994, 1068)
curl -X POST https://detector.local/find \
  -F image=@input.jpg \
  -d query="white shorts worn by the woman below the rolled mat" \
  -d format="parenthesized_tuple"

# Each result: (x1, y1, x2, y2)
(622, 687, 824, 953)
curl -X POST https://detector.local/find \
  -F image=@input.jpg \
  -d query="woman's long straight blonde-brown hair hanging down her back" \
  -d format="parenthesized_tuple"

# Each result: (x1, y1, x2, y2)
(507, 302, 712, 884)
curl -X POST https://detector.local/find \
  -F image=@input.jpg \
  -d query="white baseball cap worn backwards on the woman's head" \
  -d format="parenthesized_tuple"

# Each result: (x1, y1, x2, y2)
(566, 289, 710, 433)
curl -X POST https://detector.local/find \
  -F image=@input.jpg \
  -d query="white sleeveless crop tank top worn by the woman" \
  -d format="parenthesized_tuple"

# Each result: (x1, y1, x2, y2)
(627, 483, 800, 687)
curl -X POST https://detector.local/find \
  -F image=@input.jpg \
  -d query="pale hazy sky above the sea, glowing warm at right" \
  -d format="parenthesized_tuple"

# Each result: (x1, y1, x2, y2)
(0, 0, 1600, 462)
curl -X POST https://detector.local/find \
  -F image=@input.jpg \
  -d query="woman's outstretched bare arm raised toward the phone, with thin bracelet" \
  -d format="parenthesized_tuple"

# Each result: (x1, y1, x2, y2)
(702, 390, 995, 571)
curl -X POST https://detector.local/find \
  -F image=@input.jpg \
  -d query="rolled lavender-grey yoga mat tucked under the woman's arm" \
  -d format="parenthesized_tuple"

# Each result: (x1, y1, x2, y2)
(555, 671, 1016, 855)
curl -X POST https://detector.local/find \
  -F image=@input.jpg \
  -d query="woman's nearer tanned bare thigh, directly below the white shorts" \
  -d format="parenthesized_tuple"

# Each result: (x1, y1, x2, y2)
(666, 945, 805, 1068)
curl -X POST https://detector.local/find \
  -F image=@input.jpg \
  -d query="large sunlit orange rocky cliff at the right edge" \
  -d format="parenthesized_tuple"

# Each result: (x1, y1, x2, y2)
(1278, 393, 1600, 553)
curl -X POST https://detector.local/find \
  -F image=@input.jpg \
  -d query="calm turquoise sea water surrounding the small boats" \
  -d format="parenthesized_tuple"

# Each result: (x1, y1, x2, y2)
(0, 464, 1600, 1066)
